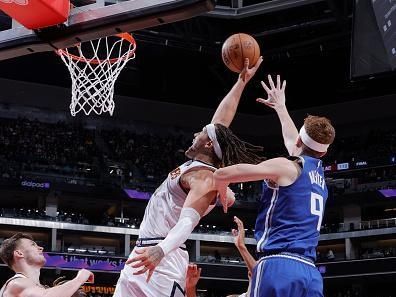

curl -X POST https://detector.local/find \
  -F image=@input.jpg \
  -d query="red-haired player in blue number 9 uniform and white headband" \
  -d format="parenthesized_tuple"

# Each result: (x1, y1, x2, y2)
(214, 76, 335, 297)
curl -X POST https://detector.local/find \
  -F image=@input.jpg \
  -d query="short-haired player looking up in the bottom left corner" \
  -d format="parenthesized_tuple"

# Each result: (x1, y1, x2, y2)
(0, 233, 93, 297)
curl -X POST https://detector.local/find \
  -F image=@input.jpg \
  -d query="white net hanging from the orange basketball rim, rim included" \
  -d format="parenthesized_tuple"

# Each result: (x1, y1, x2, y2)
(57, 33, 136, 116)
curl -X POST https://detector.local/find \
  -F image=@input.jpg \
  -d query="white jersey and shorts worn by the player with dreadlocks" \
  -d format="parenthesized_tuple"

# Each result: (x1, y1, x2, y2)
(113, 161, 216, 297)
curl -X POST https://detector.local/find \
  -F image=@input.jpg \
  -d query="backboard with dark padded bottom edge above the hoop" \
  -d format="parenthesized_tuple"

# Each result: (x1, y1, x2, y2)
(0, 0, 215, 60)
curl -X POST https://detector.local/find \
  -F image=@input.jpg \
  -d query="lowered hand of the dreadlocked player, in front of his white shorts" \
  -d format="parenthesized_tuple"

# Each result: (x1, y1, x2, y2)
(125, 245, 165, 282)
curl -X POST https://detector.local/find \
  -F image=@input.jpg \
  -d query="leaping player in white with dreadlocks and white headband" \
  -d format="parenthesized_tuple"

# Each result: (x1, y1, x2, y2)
(114, 57, 262, 297)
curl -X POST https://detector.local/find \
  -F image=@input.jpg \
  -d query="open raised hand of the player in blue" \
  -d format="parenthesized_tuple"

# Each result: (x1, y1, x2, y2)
(256, 75, 286, 110)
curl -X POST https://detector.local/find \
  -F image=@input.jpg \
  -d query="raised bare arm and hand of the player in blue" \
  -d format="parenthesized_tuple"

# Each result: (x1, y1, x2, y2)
(257, 75, 299, 156)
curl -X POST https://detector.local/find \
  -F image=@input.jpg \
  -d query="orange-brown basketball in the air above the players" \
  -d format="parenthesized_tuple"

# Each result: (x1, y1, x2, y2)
(221, 33, 260, 73)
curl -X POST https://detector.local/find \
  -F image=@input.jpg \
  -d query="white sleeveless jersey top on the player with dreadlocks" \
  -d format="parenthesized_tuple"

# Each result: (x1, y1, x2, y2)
(139, 160, 216, 239)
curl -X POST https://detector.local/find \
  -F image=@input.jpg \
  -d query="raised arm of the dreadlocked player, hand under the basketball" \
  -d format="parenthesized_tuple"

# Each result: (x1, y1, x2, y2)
(211, 57, 263, 127)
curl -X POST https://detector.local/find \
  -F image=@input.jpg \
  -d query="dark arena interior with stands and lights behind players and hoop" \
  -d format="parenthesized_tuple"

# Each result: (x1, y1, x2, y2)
(0, 0, 396, 297)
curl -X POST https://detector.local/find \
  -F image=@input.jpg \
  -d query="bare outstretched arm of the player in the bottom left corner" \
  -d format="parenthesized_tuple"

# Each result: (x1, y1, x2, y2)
(7, 269, 94, 297)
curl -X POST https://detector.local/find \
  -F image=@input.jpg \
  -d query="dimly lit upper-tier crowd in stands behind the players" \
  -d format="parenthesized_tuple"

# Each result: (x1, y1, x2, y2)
(0, 118, 396, 201)
